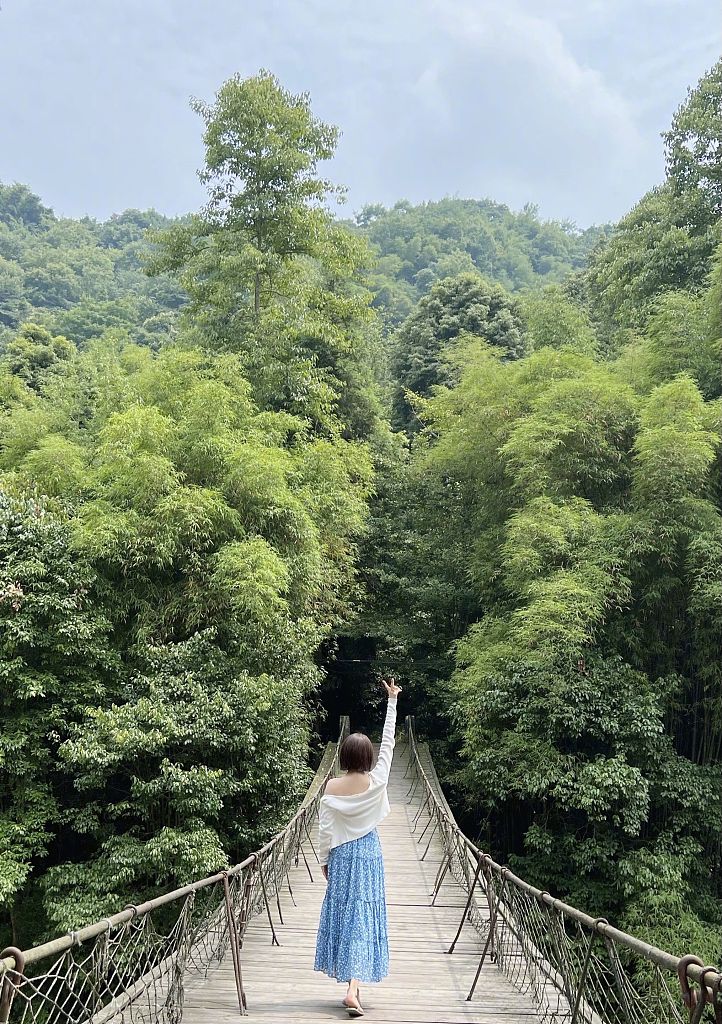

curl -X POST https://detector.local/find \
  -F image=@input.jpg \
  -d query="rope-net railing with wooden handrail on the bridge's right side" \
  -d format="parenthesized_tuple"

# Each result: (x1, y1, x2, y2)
(407, 717, 722, 1024)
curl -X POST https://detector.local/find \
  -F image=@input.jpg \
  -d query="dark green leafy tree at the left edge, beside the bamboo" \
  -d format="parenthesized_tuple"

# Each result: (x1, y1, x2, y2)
(0, 489, 119, 937)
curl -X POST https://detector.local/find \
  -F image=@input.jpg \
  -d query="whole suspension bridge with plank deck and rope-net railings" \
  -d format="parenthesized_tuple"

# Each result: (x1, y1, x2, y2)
(0, 718, 722, 1024)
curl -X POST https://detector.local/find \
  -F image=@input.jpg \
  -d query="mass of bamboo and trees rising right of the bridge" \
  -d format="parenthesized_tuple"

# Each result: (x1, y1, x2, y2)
(365, 65, 722, 963)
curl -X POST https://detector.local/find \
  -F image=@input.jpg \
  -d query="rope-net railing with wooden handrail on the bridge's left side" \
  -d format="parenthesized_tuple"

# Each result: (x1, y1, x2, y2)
(0, 717, 348, 1024)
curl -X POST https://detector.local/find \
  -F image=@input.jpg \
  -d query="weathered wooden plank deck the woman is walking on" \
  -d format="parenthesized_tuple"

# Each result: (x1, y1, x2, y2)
(183, 742, 539, 1024)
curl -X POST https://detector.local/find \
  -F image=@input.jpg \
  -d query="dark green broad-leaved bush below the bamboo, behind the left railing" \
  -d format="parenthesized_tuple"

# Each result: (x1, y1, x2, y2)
(43, 630, 308, 929)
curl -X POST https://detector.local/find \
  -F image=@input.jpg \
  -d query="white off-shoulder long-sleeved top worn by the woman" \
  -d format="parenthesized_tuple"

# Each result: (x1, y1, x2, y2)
(318, 697, 396, 864)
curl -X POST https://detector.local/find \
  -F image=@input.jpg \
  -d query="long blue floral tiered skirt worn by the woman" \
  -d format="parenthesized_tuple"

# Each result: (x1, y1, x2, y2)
(314, 828, 388, 982)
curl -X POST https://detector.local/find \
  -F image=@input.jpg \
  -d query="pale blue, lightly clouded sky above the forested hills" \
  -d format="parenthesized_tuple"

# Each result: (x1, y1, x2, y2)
(0, 0, 722, 226)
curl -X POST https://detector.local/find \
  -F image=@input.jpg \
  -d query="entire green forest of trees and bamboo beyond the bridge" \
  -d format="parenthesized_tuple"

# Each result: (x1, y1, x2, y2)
(0, 62, 722, 963)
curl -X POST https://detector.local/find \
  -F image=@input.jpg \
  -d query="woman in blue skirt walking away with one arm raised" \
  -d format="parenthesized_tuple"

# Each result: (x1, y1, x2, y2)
(314, 679, 401, 1017)
